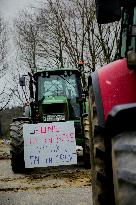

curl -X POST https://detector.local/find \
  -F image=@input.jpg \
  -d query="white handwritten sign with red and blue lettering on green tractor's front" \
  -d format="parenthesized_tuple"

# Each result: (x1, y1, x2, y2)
(23, 121, 77, 168)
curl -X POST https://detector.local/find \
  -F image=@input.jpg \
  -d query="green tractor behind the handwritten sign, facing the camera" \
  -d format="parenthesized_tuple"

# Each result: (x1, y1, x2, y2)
(10, 66, 90, 173)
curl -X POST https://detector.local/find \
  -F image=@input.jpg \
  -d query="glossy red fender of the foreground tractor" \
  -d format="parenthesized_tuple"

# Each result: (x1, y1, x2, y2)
(92, 59, 136, 124)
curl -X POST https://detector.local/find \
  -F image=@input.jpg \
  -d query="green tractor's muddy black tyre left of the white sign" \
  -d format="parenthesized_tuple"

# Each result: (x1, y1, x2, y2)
(10, 121, 28, 173)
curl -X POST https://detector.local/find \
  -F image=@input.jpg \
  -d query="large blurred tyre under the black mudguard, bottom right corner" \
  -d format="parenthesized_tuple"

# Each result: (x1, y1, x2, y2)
(112, 131, 136, 205)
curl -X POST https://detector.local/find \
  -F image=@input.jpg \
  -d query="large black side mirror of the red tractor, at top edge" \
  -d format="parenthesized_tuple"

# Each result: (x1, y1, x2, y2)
(95, 0, 121, 24)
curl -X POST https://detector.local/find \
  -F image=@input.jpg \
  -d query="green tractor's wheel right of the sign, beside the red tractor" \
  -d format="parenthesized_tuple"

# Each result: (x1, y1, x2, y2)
(83, 116, 91, 169)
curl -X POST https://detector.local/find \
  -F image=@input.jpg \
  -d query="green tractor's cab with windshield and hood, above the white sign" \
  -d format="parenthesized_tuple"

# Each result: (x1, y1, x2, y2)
(34, 69, 82, 122)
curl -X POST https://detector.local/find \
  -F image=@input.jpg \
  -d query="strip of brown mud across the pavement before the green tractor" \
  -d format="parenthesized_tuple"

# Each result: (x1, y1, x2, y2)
(0, 167, 91, 192)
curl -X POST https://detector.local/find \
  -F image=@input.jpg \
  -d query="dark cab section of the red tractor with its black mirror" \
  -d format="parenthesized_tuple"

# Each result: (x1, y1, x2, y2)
(96, 0, 136, 70)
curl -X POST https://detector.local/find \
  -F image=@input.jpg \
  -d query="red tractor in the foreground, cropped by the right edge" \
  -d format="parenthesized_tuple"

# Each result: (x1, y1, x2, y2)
(89, 0, 136, 205)
